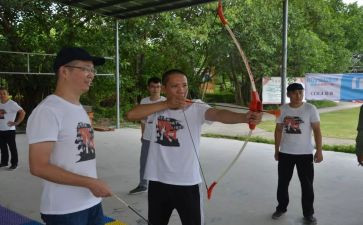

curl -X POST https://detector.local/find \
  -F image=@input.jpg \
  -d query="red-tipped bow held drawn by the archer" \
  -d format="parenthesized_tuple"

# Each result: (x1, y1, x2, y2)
(207, 0, 262, 199)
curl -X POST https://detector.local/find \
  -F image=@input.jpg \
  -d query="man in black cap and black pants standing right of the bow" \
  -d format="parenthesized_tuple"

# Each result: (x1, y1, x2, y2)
(272, 83, 323, 224)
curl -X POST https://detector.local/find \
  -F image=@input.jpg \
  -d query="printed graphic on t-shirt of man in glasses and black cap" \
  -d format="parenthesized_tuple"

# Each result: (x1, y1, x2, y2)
(74, 122, 96, 162)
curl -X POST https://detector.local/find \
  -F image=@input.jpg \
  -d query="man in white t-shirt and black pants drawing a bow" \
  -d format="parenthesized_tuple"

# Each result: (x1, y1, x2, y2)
(127, 70, 262, 225)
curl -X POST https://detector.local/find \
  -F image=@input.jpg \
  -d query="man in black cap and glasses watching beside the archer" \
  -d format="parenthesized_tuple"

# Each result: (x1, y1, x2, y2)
(26, 47, 111, 225)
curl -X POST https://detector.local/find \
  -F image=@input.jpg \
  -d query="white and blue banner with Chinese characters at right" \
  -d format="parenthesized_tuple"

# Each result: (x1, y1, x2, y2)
(305, 73, 363, 101)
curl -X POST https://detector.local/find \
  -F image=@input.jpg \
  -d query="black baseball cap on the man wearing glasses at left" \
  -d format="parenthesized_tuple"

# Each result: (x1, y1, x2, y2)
(53, 47, 105, 73)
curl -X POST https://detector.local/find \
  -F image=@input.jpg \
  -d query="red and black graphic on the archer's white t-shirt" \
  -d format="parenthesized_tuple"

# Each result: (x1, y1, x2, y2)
(156, 116, 184, 147)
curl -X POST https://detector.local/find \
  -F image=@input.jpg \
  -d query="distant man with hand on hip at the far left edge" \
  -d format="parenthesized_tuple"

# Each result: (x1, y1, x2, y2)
(0, 87, 25, 170)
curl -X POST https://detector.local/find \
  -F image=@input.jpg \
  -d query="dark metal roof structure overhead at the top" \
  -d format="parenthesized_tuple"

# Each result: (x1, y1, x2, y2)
(54, 0, 215, 19)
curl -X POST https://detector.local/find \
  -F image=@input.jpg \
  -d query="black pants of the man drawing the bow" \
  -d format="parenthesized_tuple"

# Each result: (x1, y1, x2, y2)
(148, 181, 202, 225)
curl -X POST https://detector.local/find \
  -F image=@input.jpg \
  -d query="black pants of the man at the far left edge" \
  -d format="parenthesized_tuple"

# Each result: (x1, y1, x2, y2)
(0, 130, 18, 166)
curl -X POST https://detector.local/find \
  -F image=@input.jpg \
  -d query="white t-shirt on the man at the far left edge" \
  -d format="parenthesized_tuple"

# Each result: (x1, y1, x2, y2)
(0, 99, 22, 131)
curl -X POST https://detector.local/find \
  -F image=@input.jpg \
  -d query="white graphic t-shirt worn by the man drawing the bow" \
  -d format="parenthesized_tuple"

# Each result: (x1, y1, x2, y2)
(145, 101, 210, 185)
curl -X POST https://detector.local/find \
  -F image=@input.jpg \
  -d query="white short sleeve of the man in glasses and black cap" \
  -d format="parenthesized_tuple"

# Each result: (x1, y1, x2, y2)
(26, 107, 61, 144)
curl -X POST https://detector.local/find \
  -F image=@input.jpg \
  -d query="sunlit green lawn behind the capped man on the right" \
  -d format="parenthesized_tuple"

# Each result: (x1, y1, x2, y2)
(258, 107, 359, 140)
